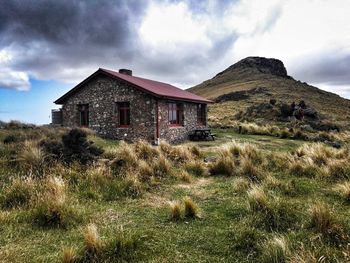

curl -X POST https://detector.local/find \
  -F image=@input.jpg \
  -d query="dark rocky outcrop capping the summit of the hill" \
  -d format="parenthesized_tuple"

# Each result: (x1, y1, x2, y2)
(216, 57, 291, 78)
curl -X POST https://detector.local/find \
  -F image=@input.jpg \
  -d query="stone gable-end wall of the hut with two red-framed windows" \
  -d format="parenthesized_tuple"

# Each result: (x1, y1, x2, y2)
(62, 75, 156, 141)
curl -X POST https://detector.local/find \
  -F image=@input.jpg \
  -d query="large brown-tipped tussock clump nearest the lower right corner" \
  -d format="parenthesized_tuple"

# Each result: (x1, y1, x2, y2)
(310, 203, 345, 243)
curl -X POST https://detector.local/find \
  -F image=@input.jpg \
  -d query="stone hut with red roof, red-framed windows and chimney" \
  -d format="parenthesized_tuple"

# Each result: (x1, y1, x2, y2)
(55, 68, 211, 143)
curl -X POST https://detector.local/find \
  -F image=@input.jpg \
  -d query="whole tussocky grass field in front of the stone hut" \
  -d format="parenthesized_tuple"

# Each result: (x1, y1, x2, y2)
(0, 128, 350, 262)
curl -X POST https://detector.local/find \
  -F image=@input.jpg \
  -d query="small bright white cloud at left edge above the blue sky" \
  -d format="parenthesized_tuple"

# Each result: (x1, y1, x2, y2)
(0, 50, 30, 91)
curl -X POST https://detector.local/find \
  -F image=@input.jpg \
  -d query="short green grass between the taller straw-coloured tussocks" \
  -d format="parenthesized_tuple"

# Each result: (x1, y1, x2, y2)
(0, 127, 350, 263)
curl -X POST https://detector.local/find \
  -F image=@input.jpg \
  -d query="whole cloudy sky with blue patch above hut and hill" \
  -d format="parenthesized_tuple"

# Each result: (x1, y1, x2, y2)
(0, 0, 350, 124)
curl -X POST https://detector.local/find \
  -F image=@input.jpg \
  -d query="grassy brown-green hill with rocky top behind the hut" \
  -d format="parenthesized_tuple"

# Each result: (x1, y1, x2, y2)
(189, 57, 350, 129)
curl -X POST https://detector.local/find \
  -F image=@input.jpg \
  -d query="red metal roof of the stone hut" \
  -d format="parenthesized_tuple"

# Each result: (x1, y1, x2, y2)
(55, 68, 212, 104)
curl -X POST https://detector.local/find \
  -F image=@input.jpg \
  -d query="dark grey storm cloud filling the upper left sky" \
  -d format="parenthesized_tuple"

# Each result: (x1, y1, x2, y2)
(0, 0, 148, 83)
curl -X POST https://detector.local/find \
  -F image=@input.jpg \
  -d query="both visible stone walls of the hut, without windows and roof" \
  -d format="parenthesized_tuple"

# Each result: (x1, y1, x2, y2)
(62, 75, 208, 143)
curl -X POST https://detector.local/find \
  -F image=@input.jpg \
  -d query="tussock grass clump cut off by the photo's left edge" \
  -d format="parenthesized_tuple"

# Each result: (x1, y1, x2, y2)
(0, 178, 34, 208)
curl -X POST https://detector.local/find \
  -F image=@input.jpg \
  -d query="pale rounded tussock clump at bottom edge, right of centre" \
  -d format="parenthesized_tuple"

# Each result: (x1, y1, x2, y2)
(259, 236, 290, 263)
